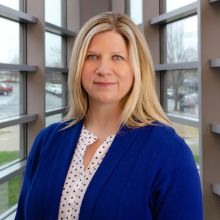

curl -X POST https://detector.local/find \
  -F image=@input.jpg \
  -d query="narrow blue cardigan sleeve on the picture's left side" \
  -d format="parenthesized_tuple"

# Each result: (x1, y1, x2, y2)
(15, 129, 45, 220)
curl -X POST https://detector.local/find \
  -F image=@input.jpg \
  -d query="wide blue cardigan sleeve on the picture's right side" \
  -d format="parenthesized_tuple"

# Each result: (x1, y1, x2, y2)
(153, 140, 203, 220)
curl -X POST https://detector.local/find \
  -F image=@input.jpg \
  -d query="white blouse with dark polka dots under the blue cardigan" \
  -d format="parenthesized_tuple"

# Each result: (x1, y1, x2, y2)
(58, 126, 115, 220)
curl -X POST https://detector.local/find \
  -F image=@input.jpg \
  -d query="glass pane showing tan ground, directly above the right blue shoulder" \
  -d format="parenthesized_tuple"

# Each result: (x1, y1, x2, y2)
(174, 123, 199, 166)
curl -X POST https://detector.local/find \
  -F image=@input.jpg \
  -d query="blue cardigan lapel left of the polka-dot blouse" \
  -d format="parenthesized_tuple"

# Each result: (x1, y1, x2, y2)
(45, 120, 83, 220)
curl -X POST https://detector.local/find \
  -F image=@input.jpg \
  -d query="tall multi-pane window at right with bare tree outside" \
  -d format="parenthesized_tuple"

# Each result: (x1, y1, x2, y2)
(160, 0, 200, 166)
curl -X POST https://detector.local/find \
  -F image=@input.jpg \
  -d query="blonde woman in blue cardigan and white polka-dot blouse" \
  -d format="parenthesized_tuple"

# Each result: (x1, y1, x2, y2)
(16, 12, 202, 220)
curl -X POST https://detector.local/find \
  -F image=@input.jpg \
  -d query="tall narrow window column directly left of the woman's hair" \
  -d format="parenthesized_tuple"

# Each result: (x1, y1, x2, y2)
(45, 0, 67, 126)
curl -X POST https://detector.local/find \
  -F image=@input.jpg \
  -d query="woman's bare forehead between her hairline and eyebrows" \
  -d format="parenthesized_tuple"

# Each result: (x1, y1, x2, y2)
(88, 31, 127, 51)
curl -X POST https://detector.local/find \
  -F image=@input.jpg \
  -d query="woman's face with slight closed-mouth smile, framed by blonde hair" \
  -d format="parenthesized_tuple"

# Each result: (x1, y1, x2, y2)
(82, 31, 134, 107)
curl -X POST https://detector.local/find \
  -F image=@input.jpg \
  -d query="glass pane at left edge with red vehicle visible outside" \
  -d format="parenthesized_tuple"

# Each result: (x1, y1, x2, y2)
(0, 71, 23, 119)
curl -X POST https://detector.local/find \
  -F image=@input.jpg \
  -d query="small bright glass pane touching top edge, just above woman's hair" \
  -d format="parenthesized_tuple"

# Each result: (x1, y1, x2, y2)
(130, 0, 143, 24)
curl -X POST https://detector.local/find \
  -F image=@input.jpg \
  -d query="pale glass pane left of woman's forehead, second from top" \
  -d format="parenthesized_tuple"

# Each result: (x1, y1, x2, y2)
(45, 32, 63, 67)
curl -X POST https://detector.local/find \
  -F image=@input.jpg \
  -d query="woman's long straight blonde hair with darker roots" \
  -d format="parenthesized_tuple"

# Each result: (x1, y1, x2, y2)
(65, 12, 171, 127)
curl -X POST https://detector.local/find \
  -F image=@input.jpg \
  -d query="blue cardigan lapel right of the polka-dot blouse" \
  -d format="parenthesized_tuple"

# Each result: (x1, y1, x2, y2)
(79, 126, 136, 220)
